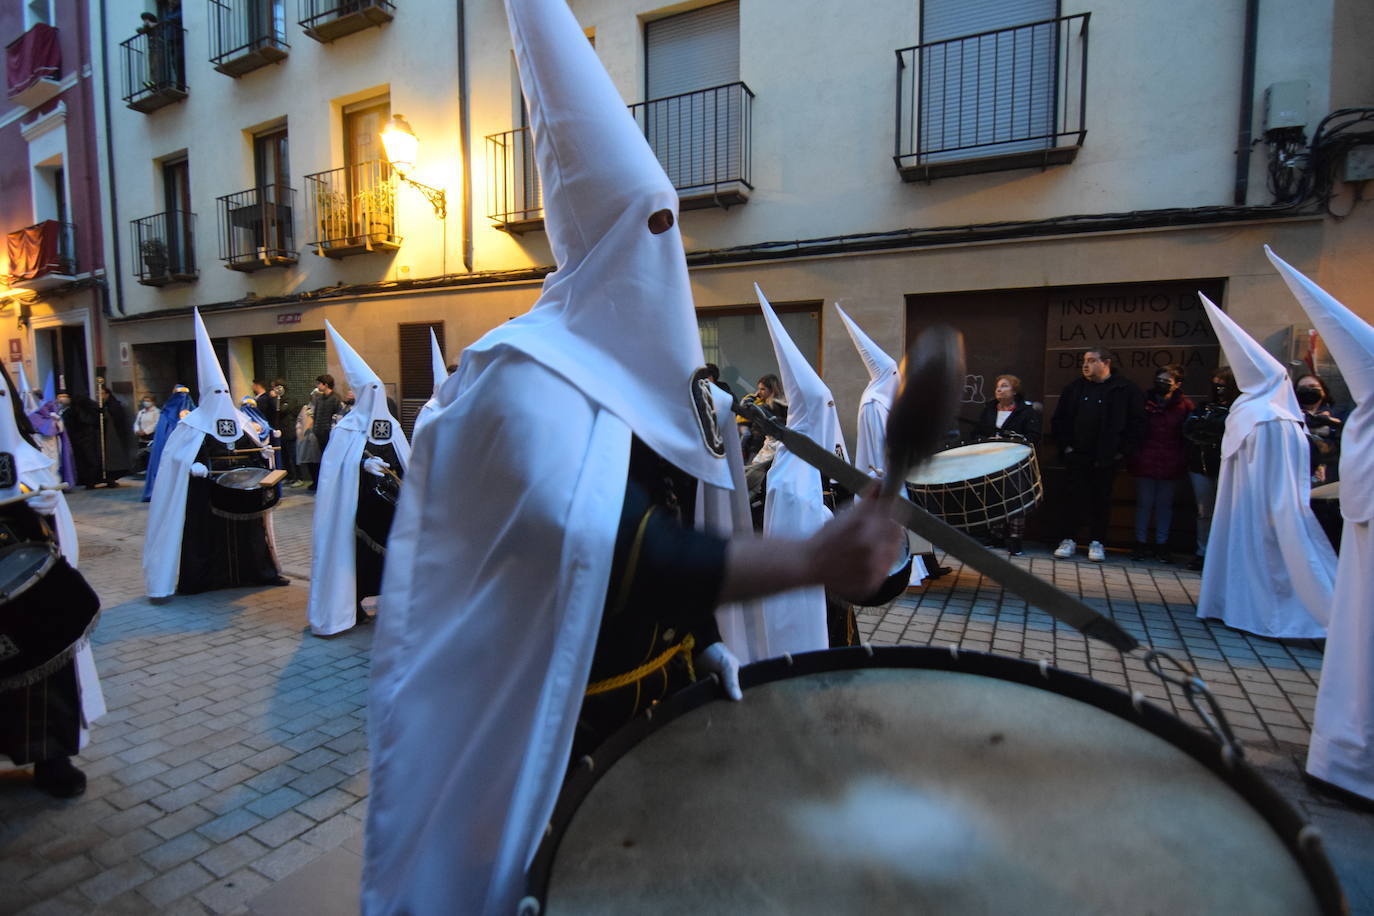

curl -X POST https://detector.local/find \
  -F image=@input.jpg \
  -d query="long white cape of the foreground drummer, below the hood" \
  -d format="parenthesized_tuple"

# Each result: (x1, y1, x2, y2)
(363, 349, 631, 915)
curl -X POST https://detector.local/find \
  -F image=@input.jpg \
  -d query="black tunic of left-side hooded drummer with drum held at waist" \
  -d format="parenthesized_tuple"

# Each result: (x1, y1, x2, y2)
(176, 434, 280, 595)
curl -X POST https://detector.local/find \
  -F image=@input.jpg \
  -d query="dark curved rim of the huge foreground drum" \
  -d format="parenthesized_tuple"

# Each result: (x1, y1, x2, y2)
(518, 645, 1348, 916)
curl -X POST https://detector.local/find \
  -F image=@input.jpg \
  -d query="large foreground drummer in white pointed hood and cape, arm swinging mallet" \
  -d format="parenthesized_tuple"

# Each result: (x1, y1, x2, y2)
(363, 0, 892, 915)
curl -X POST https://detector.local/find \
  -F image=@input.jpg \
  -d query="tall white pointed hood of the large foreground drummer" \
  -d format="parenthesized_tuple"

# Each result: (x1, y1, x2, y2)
(464, 0, 731, 489)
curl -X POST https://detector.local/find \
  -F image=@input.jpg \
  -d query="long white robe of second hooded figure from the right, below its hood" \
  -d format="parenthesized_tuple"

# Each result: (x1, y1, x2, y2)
(1197, 419, 1336, 639)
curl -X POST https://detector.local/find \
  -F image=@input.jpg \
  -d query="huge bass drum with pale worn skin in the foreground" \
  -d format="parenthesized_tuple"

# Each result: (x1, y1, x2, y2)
(519, 647, 1344, 916)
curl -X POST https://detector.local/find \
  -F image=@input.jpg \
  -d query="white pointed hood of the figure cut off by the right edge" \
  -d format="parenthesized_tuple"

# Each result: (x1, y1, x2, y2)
(1264, 246, 1374, 522)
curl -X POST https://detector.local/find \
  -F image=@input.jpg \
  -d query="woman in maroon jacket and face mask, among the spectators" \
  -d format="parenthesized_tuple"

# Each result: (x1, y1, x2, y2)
(1127, 364, 1193, 563)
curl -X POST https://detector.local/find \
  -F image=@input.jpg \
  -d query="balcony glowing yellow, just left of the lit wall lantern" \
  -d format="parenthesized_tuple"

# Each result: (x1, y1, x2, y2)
(305, 159, 401, 258)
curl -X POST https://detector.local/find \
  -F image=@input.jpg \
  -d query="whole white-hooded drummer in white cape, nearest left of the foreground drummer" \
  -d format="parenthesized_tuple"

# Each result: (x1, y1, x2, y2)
(309, 321, 411, 636)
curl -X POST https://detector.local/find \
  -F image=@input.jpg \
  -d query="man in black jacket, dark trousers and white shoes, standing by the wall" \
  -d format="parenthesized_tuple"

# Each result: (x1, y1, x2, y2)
(1050, 347, 1145, 563)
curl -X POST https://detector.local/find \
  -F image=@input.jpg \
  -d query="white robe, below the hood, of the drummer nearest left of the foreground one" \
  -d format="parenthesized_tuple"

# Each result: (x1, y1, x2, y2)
(306, 408, 411, 636)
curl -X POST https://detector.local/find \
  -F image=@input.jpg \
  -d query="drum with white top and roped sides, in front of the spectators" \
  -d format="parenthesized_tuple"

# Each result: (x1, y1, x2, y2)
(907, 439, 1044, 531)
